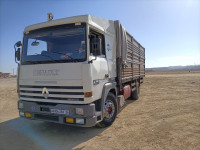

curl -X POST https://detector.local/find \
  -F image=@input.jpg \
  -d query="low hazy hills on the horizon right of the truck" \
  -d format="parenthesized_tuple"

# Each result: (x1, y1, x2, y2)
(146, 65, 200, 71)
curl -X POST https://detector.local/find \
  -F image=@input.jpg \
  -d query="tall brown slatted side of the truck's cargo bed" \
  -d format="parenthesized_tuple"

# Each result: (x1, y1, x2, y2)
(115, 21, 145, 85)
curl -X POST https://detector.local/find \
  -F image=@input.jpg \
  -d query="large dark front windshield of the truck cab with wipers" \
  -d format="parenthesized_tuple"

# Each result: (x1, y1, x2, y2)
(22, 24, 86, 64)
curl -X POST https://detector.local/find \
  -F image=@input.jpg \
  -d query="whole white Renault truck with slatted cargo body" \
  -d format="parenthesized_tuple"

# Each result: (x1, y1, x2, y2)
(14, 14, 145, 127)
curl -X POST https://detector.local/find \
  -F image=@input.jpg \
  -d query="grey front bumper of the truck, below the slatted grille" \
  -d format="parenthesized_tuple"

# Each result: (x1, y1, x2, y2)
(18, 100, 102, 127)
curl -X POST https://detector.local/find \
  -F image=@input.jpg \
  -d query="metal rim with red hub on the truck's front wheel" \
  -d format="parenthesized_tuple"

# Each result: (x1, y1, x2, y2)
(104, 100, 115, 120)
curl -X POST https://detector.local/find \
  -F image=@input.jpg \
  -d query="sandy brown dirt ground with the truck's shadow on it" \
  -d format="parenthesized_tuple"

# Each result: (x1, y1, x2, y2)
(0, 71, 200, 150)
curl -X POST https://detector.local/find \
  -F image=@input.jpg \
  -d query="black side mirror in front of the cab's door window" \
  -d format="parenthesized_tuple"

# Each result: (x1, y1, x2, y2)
(91, 38, 101, 56)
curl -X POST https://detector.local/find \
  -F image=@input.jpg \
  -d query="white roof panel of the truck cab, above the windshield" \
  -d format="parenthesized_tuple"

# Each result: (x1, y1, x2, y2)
(24, 15, 115, 33)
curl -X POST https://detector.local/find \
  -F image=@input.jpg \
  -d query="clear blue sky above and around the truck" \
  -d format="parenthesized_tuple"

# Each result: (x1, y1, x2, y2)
(0, 0, 200, 73)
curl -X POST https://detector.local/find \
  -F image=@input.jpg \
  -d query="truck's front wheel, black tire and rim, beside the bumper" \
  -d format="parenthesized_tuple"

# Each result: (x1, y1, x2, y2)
(97, 93, 118, 128)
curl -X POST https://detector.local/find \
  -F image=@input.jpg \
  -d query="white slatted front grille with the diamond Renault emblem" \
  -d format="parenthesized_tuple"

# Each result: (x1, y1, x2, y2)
(20, 85, 84, 102)
